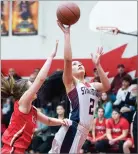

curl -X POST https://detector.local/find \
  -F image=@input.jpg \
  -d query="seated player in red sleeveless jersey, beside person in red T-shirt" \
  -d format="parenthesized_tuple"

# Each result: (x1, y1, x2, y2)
(81, 107, 106, 153)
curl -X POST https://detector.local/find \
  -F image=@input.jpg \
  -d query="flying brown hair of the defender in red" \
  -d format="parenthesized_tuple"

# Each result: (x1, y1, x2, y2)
(1, 75, 29, 100)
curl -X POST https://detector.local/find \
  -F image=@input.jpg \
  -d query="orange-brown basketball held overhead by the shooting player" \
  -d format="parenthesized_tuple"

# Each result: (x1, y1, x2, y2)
(57, 2, 80, 25)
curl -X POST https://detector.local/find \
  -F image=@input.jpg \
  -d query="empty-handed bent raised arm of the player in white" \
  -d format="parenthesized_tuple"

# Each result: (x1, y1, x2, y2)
(91, 48, 110, 92)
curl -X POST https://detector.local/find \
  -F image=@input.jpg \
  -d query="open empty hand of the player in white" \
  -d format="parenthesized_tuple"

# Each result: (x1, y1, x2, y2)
(91, 47, 103, 66)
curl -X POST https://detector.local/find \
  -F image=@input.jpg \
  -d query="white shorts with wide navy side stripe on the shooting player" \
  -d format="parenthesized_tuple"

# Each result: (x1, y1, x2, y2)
(49, 122, 89, 154)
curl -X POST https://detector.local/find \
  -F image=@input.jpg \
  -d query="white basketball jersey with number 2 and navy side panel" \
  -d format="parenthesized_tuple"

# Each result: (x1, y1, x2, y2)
(68, 82, 99, 129)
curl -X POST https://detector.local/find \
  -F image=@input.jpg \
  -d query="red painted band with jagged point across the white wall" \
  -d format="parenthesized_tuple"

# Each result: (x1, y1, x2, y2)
(1, 44, 138, 78)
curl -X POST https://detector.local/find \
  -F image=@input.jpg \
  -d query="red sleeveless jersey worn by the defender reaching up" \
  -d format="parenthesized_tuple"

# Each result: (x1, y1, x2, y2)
(2, 101, 37, 149)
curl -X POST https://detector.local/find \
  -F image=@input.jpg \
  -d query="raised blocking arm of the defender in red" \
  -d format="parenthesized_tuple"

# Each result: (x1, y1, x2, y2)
(19, 41, 58, 113)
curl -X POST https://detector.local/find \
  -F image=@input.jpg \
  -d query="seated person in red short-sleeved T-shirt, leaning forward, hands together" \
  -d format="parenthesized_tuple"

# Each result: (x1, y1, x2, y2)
(94, 109, 129, 153)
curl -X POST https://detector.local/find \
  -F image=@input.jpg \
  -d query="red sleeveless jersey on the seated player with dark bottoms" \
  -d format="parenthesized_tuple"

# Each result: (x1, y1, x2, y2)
(95, 118, 106, 138)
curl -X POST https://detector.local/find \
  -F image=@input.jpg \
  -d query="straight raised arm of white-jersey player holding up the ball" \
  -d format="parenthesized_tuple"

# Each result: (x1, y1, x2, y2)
(57, 21, 73, 92)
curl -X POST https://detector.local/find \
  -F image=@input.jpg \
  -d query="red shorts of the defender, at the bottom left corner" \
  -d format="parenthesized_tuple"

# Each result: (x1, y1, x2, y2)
(1, 144, 25, 154)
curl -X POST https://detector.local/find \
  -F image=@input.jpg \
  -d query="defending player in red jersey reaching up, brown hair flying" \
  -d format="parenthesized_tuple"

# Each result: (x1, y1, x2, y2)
(1, 41, 67, 154)
